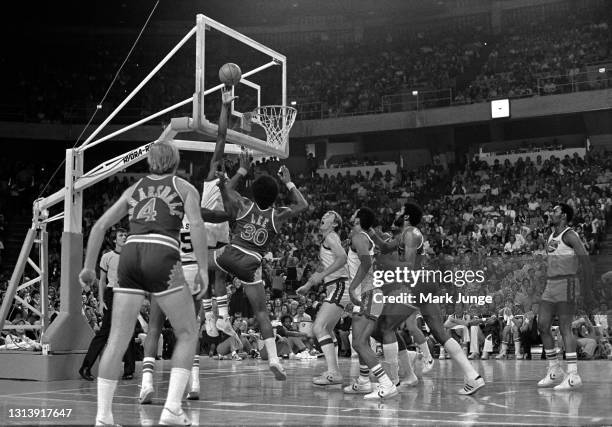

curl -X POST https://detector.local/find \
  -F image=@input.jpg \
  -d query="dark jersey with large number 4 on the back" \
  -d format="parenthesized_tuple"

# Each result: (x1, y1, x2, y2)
(129, 175, 185, 241)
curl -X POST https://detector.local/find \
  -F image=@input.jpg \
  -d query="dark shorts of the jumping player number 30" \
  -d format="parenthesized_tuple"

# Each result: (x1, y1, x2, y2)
(214, 244, 262, 285)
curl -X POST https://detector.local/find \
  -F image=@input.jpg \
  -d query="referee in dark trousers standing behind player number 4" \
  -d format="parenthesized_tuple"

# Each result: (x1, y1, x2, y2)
(79, 228, 136, 381)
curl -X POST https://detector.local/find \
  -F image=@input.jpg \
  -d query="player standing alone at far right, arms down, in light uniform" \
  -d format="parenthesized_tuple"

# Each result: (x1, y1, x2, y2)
(538, 203, 593, 390)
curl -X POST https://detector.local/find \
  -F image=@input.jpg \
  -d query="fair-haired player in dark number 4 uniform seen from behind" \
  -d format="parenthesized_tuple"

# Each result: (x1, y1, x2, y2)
(79, 142, 208, 425)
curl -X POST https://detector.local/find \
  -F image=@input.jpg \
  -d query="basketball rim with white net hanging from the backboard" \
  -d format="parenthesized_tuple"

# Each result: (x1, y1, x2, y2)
(251, 105, 297, 149)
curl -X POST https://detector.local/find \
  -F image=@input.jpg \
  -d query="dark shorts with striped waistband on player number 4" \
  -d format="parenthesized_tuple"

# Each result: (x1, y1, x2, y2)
(115, 234, 185, 296)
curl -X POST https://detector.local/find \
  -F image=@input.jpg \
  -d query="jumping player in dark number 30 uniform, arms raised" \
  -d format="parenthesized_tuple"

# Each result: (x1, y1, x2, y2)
(214, 166, 308, 380)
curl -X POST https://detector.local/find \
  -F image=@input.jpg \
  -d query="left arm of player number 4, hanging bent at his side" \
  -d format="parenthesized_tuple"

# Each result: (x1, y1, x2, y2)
(79, 185, 135, 285)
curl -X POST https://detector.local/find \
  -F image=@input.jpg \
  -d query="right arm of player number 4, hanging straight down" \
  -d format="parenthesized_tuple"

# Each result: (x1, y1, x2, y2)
(176, 179, 208, 295)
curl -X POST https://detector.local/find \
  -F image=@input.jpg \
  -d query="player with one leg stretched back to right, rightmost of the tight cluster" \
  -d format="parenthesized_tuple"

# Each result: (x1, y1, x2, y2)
(370, 202, 485, 395)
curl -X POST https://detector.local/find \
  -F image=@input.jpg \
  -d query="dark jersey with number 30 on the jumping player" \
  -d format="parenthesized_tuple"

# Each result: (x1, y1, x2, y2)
(232, 202, 277, 257)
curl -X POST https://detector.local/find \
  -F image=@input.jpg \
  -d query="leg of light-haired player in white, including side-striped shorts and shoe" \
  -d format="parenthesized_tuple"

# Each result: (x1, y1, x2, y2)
(312, 281, 344, 385)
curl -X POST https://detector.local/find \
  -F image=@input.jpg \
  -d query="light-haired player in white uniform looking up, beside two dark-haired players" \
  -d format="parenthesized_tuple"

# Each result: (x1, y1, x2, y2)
(297, 211, 348, 385)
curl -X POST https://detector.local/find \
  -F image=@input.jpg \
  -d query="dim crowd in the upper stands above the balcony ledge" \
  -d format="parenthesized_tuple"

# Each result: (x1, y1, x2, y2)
(2, 8, 612, 123)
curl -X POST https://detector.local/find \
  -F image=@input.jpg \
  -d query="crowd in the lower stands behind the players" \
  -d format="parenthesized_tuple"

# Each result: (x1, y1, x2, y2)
(0, 146, 612, 358)
